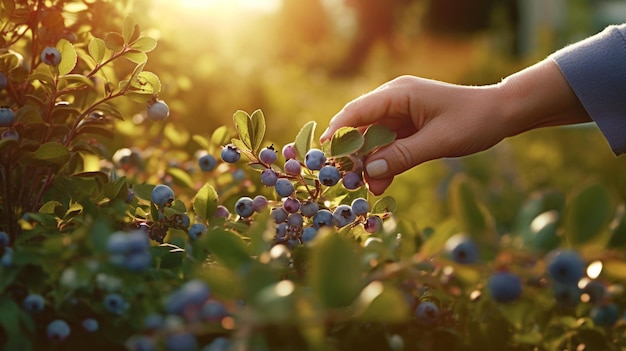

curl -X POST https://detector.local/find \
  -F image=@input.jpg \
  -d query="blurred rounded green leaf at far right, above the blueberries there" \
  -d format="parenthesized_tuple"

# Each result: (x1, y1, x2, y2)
(565, 183, 613, 246)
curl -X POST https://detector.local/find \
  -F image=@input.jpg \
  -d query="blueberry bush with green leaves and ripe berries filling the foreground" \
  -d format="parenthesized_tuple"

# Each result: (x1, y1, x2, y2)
(0, 0, 626, 351)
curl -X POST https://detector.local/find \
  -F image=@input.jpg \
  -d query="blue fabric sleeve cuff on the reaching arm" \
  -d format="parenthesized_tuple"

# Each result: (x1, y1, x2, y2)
(550, 24, 626, 155)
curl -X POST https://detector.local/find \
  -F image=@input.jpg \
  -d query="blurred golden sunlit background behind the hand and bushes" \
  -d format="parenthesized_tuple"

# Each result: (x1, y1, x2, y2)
(114, 0, 626, 232)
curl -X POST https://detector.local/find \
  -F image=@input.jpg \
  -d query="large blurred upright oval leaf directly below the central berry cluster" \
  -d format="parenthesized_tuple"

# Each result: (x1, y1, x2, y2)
(309, 232, 363, 308)
